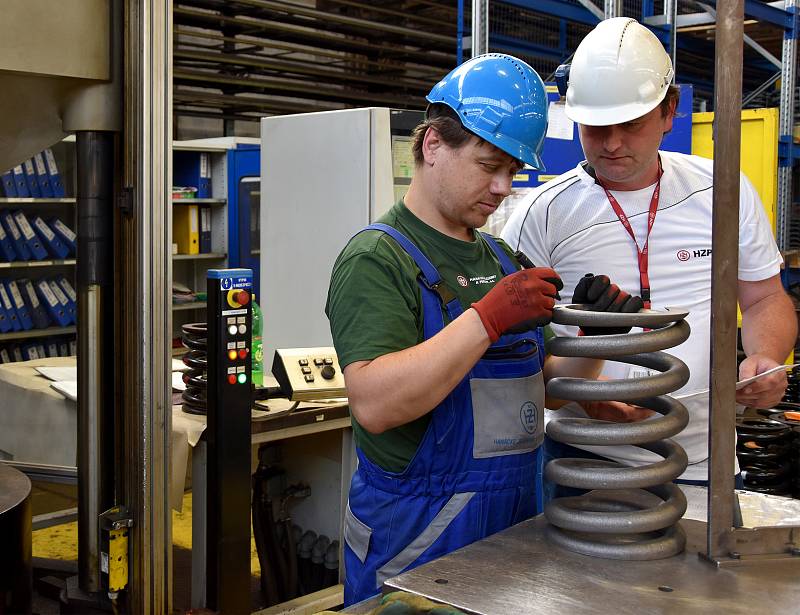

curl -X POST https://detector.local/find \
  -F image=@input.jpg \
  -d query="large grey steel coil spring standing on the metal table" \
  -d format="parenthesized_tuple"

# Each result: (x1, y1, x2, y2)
(544, 305, 689, 560)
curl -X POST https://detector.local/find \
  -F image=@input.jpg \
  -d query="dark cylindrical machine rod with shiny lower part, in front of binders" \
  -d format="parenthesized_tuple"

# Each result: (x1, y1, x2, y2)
(76, 131, 116, 592)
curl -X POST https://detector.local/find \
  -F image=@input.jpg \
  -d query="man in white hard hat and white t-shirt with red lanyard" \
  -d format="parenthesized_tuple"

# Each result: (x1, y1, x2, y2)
(502, 18, 797, 495)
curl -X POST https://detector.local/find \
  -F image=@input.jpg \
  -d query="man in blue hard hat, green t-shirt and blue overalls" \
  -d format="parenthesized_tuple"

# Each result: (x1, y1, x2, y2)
(326, 54, 641, 604)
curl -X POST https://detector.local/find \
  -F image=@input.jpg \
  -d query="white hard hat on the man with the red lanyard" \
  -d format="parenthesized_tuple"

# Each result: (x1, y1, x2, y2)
(564, 17, 672, 126)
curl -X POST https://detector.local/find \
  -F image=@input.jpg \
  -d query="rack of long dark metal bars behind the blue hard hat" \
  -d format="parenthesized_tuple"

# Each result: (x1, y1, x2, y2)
(173, 0, 458, 122)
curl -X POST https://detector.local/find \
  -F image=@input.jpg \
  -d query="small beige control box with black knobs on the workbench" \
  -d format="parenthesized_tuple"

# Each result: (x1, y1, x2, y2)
(272, 347, 347, 401)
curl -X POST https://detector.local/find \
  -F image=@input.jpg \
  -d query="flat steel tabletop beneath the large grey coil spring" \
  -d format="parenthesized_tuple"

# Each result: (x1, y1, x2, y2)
(384, 516, 800, 615)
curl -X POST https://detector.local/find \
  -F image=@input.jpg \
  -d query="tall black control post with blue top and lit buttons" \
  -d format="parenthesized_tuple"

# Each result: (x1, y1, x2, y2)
(203, 269, 253, 613)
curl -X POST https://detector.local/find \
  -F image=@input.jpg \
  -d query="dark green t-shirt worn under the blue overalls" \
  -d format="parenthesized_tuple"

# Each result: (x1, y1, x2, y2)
(325, 201, 540, 472)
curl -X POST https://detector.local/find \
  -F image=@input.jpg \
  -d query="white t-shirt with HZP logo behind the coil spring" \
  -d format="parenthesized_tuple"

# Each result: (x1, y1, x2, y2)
(502, 152, 782, 480)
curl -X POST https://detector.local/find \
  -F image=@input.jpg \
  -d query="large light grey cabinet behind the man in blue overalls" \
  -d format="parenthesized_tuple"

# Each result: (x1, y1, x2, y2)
(259, 108, 423, 364)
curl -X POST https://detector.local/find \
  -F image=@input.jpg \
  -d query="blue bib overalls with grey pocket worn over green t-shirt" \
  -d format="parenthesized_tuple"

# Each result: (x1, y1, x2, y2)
(344, 224, 544, 605)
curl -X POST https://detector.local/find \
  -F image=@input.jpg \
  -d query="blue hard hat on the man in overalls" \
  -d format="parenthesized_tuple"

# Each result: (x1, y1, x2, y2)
(426, 53, 547, 170)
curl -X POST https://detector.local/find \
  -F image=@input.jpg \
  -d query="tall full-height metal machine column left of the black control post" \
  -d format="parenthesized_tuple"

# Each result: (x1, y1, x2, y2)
(122, 0, 172, 615)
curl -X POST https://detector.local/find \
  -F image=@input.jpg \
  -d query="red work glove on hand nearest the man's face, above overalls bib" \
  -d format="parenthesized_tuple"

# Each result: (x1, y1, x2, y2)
(472, 267, 564, 343)
